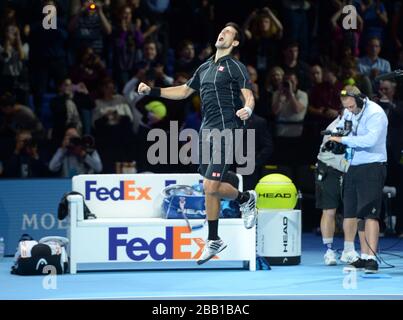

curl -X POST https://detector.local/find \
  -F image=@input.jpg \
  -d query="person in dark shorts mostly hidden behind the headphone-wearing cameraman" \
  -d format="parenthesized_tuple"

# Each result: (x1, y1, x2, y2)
(315, 116, 349, 266)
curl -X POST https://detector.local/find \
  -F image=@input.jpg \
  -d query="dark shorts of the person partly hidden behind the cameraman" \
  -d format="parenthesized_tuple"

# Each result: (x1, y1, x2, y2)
(315, 161, 343, 210)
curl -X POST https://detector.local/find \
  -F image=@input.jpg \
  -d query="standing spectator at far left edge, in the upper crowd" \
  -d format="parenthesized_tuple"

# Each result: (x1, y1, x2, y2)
(0, 24, 29, 104)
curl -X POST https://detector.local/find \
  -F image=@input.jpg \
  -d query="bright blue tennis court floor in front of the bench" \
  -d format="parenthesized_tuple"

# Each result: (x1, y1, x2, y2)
(0, 234, 403, 300)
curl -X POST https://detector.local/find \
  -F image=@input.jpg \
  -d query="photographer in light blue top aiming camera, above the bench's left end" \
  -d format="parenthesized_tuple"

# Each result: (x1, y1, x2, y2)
(49, 127, 102, 178)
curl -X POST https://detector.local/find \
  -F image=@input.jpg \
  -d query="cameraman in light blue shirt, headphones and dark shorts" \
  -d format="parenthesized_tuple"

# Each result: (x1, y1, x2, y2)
(329, 86, 388, 273)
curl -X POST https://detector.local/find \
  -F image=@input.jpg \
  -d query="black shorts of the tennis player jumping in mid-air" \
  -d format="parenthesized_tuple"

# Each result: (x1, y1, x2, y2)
(198, 129, 235, 181)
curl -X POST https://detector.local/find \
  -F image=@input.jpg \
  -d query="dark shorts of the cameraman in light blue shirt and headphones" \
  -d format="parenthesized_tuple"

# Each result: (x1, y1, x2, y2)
(343, 162, 386, 219)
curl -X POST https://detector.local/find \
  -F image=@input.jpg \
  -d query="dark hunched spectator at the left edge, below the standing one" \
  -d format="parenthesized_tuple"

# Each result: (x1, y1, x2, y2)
(0, 92, 43, 139)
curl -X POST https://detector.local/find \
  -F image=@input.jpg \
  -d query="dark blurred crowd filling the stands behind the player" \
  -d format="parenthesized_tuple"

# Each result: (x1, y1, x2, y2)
(0, 0, 403, 232)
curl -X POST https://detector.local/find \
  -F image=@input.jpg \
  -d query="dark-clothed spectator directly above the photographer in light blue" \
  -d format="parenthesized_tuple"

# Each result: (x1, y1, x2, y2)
(50, 78, 95, 145)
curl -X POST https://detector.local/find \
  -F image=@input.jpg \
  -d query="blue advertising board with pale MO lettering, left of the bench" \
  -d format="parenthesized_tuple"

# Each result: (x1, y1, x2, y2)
(0, 179, 71, 255)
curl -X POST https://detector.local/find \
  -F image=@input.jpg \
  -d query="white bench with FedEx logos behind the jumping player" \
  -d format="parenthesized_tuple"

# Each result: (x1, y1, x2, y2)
(68, 174, 256, 274)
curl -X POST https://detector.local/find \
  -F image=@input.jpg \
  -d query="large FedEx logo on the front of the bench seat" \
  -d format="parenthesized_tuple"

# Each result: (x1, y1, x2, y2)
(109, 227, 217, 261)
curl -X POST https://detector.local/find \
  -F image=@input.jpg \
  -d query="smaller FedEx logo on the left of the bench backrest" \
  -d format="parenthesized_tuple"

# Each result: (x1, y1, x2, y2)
(85, 180, 151, 201)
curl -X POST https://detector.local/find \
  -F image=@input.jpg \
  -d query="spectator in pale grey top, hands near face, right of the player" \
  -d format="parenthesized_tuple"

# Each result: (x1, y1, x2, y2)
(272, 73, 308, 137)
